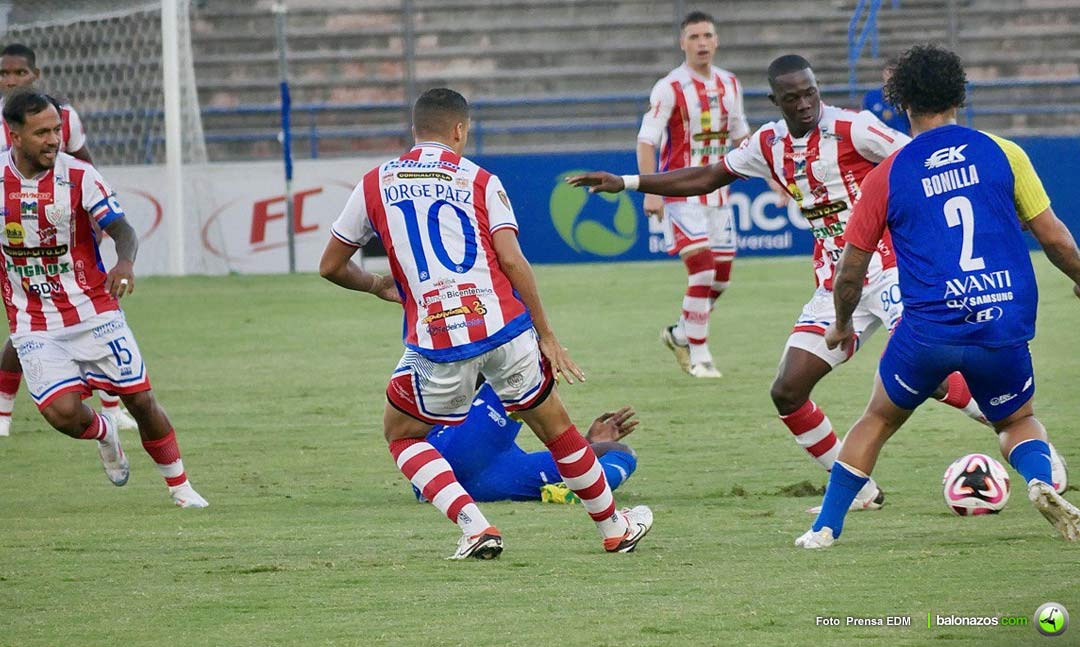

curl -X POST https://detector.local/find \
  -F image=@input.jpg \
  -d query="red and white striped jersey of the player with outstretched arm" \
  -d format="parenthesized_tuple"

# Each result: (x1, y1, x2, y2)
(723, 104, 910, 289)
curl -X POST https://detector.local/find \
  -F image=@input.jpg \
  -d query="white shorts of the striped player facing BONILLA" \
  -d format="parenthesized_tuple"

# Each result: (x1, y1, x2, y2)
(784, 269, 904, 368)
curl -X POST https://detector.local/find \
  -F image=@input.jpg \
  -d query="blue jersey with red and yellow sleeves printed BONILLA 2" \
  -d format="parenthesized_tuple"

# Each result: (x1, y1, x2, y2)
(845, 125, 1050, 348)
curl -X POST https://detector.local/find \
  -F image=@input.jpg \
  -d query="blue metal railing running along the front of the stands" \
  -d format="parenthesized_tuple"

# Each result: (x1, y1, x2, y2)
(84, 78, 1080, 163)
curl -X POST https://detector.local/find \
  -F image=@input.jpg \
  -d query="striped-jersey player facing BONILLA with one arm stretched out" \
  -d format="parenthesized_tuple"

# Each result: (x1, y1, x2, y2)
(569, 54, 985, 509)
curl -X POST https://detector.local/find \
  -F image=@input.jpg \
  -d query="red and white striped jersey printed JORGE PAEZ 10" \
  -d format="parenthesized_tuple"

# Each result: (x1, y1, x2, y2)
(330, 141, 532, 362)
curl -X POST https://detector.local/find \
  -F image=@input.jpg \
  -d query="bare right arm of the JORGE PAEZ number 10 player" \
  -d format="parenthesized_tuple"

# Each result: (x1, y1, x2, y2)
(491, 227, 585, 385)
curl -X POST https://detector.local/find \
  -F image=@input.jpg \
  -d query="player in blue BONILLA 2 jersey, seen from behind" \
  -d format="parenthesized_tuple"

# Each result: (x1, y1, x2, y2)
(795, 45, 1080, 549)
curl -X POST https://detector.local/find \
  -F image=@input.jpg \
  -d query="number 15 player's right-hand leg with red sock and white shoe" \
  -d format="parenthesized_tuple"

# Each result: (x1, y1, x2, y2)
(121, 390, 210, 508)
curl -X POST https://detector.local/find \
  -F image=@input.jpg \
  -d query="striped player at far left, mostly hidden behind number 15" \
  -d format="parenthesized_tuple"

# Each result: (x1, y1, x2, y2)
(0, 43, 136, 436)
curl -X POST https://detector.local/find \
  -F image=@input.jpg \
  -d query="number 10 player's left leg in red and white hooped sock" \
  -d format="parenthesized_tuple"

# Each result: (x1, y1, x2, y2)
(382, 403, 502, 560)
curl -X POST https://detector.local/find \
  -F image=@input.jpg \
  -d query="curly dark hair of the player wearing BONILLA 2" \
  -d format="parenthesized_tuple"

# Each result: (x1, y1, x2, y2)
(885, 44, 968, 114)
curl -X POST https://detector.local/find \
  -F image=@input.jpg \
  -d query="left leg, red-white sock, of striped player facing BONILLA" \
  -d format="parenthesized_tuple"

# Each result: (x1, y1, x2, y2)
(769, 346, 885, 512)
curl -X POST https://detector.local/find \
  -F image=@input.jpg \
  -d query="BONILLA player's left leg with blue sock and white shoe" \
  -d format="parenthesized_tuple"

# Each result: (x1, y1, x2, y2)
(795, 375, 912, 549)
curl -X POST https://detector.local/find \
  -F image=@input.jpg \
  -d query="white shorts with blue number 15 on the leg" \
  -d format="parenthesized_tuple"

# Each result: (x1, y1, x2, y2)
(11, 310, 150, 409)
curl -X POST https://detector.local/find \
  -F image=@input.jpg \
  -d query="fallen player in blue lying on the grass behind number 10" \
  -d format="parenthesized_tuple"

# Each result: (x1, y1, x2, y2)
(413, 383, 638, 503)
